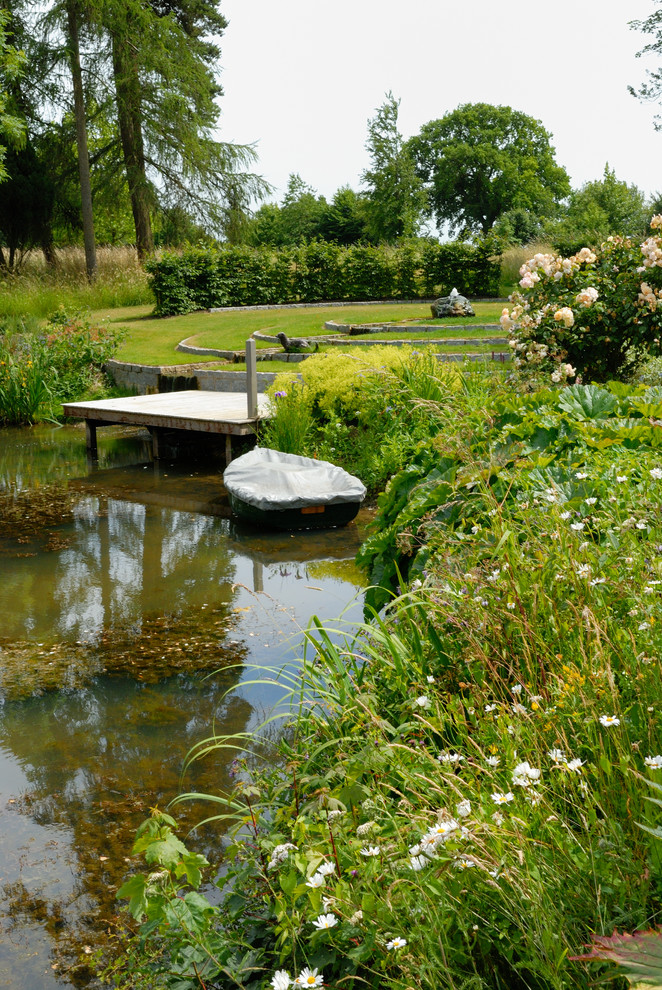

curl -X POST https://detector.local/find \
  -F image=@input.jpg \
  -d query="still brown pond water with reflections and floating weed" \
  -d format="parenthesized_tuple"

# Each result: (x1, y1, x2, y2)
(0, 427, 362, 990)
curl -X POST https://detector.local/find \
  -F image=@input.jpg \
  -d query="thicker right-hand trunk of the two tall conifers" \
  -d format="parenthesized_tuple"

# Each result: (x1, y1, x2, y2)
(112, 24, 154, 261)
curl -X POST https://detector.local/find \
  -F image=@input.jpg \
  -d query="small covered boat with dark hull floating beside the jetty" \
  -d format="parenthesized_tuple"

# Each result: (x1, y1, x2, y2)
(223, 447, 366, 529)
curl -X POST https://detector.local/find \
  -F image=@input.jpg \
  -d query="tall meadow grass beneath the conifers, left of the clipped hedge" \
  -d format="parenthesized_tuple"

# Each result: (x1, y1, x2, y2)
(0, 247, 154, 319)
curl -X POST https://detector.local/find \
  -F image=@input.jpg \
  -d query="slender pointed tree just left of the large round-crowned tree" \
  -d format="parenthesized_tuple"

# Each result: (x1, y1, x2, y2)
(361, 93, 425, 243)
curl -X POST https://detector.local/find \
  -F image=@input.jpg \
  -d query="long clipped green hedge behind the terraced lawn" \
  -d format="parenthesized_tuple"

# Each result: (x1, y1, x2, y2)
(146, 241, 501, 316)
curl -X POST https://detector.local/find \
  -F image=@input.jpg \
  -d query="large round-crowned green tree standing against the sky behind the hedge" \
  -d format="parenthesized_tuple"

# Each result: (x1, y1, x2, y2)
(407, 103, 570, 234)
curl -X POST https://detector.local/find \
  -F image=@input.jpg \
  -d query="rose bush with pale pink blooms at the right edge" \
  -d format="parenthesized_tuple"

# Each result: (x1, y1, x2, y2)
(500, 214, 662, 384)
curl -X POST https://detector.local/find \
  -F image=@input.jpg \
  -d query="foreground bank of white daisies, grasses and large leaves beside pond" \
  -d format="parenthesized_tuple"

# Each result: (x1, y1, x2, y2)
(109, 356, 662, 990)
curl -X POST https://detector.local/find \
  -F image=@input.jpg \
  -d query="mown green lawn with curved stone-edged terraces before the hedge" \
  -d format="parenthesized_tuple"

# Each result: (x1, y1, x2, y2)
(92, 302, 503, 365)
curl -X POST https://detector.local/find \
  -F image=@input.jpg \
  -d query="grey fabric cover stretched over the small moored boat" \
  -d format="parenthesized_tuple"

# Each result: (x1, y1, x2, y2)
(223, 447, 366, 512)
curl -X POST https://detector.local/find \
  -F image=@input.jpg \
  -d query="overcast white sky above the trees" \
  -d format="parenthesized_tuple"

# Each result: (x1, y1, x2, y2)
(219, 0, 662, 207)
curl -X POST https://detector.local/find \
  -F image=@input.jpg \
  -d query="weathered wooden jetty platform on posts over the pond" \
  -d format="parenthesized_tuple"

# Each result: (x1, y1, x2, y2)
(62, 390, 269, 461)
